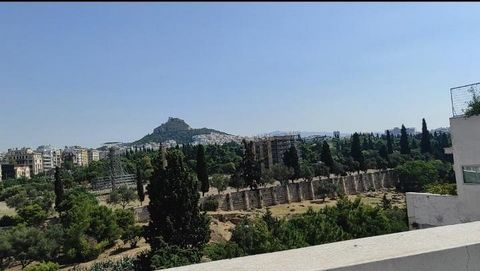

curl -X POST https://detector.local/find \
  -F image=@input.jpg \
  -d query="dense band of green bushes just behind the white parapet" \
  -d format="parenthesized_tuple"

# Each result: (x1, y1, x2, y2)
(226, 197, 408, 259)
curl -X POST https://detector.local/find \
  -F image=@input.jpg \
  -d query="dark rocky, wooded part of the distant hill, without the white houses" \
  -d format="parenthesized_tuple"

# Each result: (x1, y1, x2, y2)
(131, 117, 230, 145)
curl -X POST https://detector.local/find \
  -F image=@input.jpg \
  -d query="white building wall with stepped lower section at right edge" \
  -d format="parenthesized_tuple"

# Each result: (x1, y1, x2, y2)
(406, 113, 480, 228)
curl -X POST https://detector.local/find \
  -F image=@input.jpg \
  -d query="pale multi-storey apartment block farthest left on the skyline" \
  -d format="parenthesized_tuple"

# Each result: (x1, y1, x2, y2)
(5, 148, 43, 175)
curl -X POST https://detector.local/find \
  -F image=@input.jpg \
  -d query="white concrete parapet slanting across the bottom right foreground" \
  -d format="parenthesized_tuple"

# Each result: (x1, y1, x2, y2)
(167, 222, 480, 271)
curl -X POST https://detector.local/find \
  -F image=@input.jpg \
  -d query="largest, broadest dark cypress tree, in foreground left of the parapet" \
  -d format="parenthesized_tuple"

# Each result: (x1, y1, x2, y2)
(144, 149, 210, 251)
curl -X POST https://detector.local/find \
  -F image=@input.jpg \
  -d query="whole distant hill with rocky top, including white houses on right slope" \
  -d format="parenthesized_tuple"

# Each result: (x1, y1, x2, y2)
(132, 117, 236, 145)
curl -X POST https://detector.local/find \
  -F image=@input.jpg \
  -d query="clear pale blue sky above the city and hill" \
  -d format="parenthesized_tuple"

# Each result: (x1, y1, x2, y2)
(0, 3, 480, 150)
